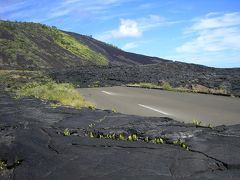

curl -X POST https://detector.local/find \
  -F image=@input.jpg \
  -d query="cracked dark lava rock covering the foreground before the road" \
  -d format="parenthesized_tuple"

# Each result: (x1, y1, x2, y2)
(0, 85, 240, 180)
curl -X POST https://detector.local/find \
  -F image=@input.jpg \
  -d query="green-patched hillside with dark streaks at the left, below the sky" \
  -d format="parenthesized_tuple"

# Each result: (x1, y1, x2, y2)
(0, 21, 109, 68)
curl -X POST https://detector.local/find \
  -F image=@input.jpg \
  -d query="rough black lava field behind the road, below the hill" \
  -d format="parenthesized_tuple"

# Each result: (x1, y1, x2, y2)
(49, 61, 240, 96)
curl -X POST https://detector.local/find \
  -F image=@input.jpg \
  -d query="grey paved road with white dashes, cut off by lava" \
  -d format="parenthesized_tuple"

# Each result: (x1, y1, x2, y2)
(79, 87, 240, 125)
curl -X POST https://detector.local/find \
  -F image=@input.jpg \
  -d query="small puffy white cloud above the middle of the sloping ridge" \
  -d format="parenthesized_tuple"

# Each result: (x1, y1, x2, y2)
(111, 19, 142, 38)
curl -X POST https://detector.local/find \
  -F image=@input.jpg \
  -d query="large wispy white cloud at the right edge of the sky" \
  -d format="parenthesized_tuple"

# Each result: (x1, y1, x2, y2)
(176, 13, 240, 53)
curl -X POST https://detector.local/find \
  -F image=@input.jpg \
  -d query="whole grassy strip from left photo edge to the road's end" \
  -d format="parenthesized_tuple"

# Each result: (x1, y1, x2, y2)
(0, 70, 95, 109)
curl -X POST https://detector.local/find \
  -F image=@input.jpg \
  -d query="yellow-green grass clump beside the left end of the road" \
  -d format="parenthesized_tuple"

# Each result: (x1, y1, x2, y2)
(16, 80, 95, 109)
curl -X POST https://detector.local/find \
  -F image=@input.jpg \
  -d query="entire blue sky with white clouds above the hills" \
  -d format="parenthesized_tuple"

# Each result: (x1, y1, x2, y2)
(0, 0, 240, 67)
